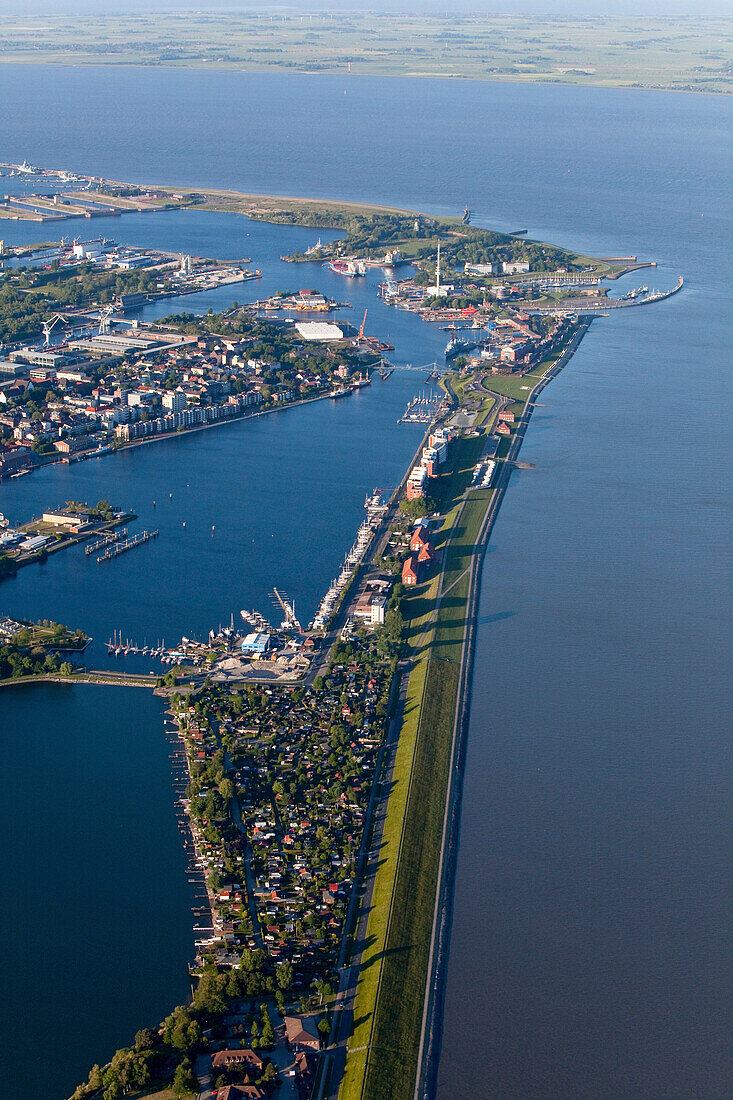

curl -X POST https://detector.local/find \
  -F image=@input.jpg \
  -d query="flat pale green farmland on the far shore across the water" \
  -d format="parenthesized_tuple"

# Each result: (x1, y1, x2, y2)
(0, 14, 733, 92)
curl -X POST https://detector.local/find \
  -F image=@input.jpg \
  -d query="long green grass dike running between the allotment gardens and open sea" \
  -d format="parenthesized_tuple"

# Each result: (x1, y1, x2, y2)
(339, 413, 493, 1100)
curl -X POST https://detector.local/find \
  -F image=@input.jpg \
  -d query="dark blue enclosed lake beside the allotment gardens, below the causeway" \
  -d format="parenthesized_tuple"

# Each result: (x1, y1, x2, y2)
(0, 684, 194, 1100)
